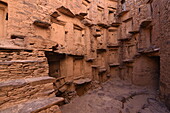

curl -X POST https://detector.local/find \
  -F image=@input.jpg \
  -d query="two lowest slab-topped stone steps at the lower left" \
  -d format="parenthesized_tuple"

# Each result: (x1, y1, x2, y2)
(0, 76, 64, 113)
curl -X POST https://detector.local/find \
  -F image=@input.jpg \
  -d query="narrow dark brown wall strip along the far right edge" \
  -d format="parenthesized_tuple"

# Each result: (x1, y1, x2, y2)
(155, 0, 170, 108)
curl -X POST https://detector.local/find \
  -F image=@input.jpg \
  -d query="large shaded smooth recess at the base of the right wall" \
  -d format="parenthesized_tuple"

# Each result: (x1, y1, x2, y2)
(133, 56, 160, 89)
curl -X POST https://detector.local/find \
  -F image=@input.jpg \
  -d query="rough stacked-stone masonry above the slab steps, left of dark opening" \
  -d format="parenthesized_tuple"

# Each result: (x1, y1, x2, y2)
(0, 51, 48, 81)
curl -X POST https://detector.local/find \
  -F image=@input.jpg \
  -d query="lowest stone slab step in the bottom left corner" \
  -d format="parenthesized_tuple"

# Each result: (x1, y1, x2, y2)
(0, 97, 63, 113)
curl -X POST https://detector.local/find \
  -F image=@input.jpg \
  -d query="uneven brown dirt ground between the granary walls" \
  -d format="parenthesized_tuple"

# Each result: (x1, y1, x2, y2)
(61, 79, 170, 113)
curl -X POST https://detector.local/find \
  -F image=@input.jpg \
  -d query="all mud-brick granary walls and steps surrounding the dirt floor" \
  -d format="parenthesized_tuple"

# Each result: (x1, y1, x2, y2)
(0, 0, 170, 113)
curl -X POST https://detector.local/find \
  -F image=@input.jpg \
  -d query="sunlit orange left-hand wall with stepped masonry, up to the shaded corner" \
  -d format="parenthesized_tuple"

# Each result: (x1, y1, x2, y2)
(0, 0, 120, 112)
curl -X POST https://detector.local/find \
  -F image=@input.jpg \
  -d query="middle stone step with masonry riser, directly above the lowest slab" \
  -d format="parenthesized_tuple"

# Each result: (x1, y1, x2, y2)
(0, 79, 54, 108)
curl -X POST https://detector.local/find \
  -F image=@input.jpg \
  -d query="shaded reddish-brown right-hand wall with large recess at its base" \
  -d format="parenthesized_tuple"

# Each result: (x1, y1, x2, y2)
(118, 0, 169, 108)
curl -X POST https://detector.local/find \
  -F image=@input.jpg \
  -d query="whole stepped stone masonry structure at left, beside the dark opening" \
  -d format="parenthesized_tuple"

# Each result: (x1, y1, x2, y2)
(0, 40, 64, 113)
